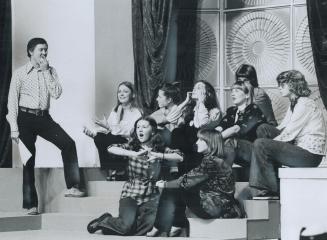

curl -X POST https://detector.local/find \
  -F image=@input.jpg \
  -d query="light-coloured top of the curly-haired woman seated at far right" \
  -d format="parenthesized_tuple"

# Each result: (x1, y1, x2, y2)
(274, 97, 326, 155)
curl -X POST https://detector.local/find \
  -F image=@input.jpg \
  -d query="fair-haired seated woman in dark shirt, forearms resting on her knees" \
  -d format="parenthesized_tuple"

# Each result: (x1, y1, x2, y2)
(216, 81, 266, 166)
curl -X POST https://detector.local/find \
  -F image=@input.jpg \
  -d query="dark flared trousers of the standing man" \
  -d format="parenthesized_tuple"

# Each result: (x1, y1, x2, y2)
(17, 111, 80, 208)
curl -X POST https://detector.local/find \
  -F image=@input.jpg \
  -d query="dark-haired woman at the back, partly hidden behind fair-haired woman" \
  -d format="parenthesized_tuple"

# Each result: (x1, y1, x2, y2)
(235, 64, 277, 126)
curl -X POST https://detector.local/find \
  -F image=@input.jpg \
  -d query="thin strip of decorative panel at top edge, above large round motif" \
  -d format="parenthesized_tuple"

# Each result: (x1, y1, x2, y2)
(225, 0, 291, 9)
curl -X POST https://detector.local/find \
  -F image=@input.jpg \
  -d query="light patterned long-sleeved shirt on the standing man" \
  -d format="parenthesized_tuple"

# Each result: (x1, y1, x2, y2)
(7, 62, 62, 132)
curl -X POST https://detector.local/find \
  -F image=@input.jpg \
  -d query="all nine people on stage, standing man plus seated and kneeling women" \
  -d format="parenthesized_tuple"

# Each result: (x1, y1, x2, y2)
(7, 38, 326, 237)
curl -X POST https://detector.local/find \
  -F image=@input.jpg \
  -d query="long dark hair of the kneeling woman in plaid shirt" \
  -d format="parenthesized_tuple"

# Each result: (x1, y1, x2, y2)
(129, 116, 165, 152)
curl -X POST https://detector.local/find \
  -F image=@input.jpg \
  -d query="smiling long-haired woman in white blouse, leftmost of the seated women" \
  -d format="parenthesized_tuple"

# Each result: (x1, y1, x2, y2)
(84, 82, 142, 180)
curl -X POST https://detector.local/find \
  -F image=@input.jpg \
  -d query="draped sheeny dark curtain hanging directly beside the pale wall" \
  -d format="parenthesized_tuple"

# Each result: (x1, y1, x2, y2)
(132, 0, 174, 113)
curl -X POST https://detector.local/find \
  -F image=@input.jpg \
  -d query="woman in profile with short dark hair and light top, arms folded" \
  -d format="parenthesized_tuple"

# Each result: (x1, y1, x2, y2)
(150, 83, 182, 146)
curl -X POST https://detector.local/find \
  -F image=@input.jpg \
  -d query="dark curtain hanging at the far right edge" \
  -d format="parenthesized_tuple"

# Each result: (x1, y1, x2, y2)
(307, 0, 327, 107)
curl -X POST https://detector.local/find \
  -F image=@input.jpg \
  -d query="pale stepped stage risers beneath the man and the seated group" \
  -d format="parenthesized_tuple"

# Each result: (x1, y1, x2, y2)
(0, 169, 280, 239)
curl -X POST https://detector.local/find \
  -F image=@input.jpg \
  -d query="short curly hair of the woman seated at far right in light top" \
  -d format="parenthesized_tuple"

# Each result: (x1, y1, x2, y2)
(276, 70, 311, 97)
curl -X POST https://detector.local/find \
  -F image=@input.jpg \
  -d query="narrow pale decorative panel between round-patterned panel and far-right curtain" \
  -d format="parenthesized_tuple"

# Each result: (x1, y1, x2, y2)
(294, 6, 317, 84)
